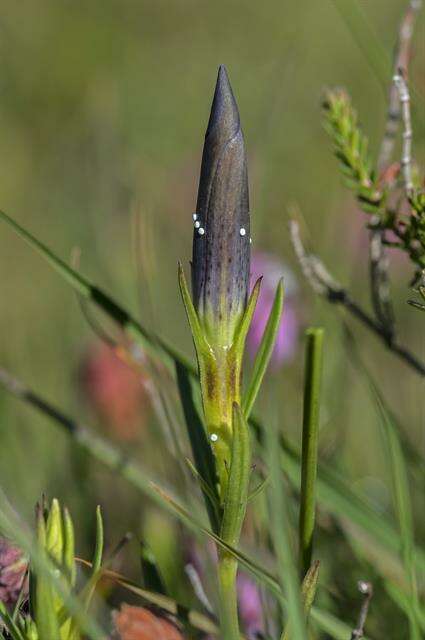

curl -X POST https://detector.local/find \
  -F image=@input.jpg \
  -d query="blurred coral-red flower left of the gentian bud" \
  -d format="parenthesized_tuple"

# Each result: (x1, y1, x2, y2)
(80, 343, 149, 440)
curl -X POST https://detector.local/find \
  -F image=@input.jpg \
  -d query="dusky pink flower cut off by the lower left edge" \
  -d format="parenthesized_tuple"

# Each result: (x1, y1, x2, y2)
(0, 538, 28, 605)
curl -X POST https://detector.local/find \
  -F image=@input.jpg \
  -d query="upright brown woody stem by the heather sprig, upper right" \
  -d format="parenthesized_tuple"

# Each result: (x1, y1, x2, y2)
(369, 0, 422, 337)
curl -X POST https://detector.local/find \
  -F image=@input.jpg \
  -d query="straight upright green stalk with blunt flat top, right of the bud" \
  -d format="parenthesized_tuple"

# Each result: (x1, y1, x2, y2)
(299, 329, 323, 576)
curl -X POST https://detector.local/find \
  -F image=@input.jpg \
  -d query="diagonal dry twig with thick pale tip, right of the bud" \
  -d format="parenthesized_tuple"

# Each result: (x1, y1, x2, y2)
(289, 220, 425, 377)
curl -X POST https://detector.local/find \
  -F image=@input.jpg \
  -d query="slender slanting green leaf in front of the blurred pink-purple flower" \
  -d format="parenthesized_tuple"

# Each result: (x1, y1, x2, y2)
(242, 280, 284, 419)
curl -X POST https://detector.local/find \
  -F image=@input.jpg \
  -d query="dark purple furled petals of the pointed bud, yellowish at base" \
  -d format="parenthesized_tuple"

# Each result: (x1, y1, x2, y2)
(192, 66, 250, 346)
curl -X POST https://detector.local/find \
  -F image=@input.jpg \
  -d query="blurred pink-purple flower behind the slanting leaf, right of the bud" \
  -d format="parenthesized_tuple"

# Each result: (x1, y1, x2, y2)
(247, 252, 299, 369)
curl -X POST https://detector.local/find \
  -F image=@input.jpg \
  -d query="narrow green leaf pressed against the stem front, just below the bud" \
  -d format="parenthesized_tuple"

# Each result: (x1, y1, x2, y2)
(220, 402, 251, 545)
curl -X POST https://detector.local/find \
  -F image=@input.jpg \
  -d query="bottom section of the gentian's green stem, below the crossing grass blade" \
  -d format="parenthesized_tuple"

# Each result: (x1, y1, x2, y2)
(218, 551, 240, 640)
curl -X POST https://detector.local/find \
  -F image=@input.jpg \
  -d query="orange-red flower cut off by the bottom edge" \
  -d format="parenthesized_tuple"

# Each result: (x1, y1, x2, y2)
(114, 604, 184, 640)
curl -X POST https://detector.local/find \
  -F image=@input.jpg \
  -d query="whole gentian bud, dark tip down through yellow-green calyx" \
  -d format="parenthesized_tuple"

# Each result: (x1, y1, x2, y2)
(179, 66, 260, 503)
